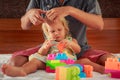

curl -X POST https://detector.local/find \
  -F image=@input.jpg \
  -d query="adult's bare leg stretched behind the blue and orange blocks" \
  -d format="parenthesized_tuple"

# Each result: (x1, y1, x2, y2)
(75, 58, 105, 74)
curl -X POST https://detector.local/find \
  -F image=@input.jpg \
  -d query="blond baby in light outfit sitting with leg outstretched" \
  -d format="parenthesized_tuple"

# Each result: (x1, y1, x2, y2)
(2, 18, 81, 77)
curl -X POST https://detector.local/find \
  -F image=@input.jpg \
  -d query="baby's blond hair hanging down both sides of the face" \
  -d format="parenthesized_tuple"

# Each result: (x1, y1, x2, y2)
(42, 18, 70, 39)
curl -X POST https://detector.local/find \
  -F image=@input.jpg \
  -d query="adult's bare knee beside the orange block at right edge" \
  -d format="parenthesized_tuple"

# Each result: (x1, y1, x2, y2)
(97, 53, 115, 66)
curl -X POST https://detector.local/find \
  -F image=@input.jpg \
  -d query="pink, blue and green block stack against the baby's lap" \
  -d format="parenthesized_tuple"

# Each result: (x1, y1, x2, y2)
(46, 53, 75, 73)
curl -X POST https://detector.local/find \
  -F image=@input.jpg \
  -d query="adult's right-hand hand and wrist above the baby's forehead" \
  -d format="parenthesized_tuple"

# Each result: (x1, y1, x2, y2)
(46, 6, 71, 21)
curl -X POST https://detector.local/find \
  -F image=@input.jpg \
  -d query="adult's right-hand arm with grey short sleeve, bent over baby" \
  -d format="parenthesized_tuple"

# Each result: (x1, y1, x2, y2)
(46, 0, 104, 30)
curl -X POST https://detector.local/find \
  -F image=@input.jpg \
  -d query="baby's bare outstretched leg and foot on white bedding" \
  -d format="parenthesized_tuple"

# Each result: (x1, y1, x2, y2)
(2, 59, 45, 77)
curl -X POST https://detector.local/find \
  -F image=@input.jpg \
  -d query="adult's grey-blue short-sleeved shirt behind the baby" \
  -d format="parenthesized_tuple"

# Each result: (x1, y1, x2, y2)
(27, 0, 101, 58)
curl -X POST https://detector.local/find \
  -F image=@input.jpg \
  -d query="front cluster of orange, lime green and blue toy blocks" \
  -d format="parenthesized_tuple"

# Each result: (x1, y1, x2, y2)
(55, 64, 93, 80)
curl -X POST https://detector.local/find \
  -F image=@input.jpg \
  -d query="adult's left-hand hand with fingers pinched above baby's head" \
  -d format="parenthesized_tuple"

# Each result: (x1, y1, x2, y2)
(26, 9, 46, 25)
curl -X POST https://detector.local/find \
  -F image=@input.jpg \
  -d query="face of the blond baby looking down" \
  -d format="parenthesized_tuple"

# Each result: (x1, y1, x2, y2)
(47, 21, 66, 42)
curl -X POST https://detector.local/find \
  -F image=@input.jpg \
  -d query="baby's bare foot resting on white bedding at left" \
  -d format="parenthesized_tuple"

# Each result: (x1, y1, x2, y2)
(2, 64, 27, 77)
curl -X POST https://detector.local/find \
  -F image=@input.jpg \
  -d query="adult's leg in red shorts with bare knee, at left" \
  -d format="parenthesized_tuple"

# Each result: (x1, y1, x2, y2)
(8, 45, 41, 67)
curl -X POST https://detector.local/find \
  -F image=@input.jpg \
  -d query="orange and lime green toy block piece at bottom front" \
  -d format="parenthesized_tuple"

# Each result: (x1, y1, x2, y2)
(56, 66, 80, 80)
